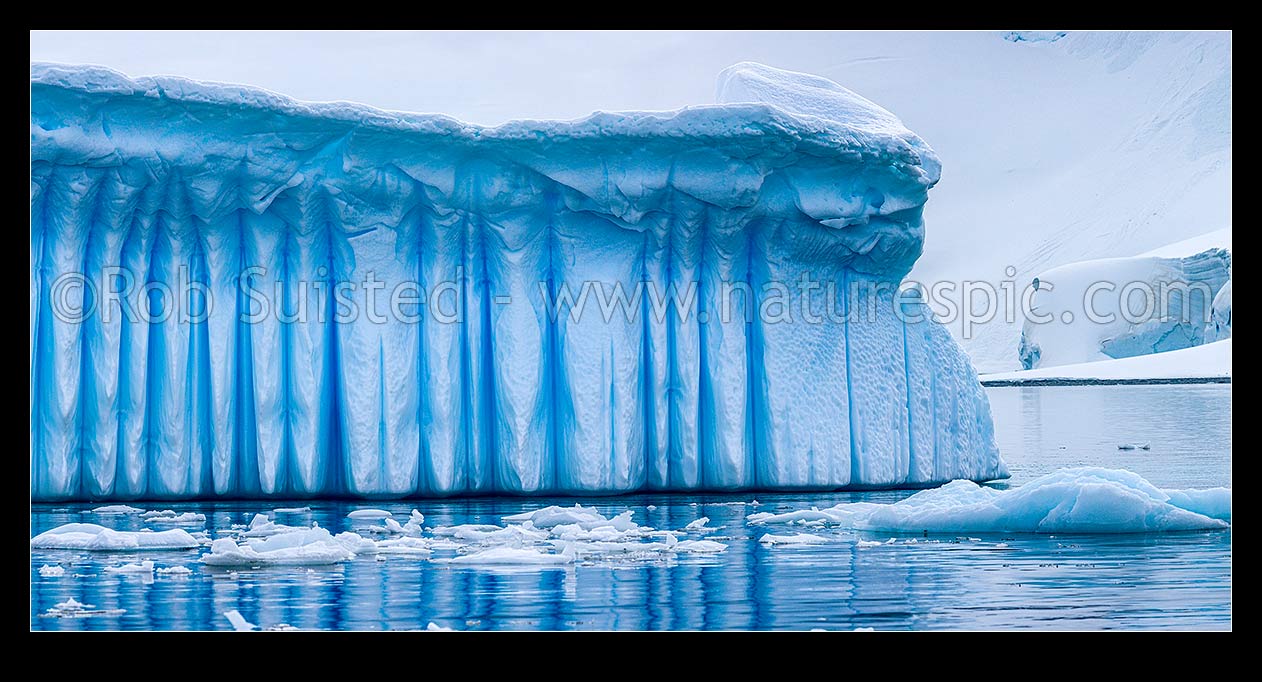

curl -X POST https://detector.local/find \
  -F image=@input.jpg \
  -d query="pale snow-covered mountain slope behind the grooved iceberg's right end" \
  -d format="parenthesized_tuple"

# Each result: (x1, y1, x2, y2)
(878, 32, 1232, 371)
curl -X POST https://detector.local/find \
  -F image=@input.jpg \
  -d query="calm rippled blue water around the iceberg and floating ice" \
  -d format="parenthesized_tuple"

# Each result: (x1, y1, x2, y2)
(30, 385, 1232, 630)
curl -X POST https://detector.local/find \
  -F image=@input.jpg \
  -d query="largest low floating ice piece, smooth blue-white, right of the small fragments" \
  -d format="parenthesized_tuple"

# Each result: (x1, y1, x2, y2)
(807, 467, 1232, 539)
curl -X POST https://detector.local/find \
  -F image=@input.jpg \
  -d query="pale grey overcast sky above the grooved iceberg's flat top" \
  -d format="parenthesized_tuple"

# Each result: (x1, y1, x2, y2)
(30, 32, 959, 124)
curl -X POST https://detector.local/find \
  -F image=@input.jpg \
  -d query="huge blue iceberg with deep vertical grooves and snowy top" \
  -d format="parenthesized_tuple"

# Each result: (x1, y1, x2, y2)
(30, 66, 1006, 500)
